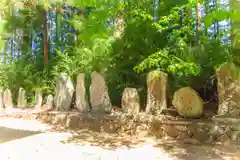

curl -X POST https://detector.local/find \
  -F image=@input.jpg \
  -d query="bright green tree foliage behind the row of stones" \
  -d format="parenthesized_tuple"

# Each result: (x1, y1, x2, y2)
(0, 0, 240, 105)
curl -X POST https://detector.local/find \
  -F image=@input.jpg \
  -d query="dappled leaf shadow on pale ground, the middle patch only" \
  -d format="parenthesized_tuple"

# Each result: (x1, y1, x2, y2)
(59, 130, 146, 150)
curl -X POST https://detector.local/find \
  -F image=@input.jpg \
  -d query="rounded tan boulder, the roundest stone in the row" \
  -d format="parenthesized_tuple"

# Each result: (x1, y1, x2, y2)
(172, 87, 203, 118)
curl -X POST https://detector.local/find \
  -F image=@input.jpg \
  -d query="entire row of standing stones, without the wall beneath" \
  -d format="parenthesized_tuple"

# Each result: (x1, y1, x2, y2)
(0, 63, 240, 118)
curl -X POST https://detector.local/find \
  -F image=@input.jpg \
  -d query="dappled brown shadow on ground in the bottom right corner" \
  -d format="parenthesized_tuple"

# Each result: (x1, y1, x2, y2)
(154, 141, 240, 160)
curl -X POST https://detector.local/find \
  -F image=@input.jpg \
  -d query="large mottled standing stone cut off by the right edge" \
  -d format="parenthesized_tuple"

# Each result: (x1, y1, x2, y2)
(216, 63, 240, 116)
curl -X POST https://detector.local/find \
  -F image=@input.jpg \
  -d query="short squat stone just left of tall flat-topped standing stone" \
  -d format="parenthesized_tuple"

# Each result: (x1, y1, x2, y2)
(122, 88, 140, 115)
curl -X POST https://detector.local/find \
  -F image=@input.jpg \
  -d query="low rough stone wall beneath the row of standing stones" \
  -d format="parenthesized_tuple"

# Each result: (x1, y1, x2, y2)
(0, 111, 240, 143)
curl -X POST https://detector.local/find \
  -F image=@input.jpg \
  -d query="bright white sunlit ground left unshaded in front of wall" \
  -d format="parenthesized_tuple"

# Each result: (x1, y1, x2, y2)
(0, 118, 176, 160)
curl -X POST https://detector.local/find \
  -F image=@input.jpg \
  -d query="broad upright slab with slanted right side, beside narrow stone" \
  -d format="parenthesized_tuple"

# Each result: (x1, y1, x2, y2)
(90, 72, 112, 112)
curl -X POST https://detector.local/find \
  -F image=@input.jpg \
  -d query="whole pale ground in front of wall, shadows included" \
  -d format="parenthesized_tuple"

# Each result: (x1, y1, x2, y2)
(0, 118, 240, 160)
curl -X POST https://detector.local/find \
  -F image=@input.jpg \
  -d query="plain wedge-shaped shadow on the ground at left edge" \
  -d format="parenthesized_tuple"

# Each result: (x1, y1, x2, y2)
(0, 127, 41, 145)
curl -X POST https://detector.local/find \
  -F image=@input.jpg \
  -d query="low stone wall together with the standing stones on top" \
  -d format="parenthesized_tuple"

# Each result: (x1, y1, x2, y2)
(0, 68, 240, 142)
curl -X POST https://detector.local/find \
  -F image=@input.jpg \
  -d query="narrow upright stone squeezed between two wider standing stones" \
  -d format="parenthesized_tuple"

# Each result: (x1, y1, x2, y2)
(76, 73, 90, 112)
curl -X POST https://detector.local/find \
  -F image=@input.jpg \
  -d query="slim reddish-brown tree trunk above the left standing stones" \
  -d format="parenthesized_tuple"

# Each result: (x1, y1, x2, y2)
(43, 11, 49, 66)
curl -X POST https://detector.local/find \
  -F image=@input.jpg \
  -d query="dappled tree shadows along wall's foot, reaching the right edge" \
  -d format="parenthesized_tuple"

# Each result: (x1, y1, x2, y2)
(58, 130, 240, 160)
